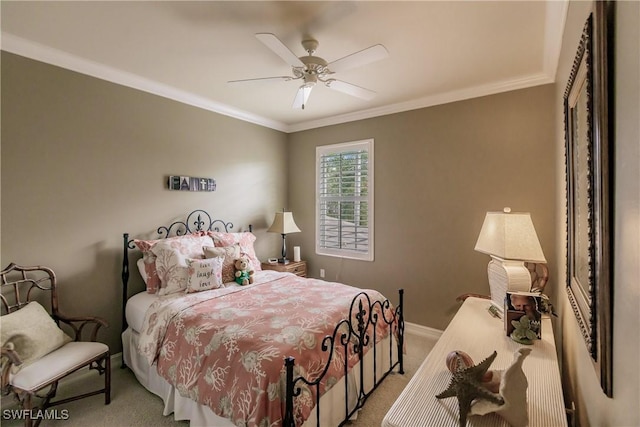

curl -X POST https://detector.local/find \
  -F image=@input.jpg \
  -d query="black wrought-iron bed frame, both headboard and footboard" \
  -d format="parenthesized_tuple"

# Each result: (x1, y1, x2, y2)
(121, 209, 404, 427)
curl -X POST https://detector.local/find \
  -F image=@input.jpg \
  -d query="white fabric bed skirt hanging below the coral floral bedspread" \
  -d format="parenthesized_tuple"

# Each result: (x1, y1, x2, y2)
(122, 327, 398, 427)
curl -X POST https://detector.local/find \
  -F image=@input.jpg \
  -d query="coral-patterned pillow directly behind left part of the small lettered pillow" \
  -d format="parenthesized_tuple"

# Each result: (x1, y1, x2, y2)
(146, 234, 213, 295)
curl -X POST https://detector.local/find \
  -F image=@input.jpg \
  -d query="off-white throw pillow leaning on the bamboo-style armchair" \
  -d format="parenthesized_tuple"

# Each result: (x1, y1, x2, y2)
(0, 301, 73, 372)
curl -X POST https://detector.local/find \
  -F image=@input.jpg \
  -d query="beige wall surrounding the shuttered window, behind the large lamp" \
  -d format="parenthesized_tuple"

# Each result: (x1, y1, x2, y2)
(288, 85, 557, 329)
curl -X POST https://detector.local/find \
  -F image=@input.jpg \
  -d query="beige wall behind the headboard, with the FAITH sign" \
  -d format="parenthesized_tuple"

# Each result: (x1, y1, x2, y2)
(0, 52, 287, 352)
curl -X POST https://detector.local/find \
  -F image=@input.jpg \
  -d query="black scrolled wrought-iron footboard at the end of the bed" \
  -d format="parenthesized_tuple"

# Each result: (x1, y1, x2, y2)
(283, 289, 404, 427)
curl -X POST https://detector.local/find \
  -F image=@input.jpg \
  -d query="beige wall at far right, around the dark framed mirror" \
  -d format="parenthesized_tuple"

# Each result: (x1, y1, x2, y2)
(555, 1, 640, 426)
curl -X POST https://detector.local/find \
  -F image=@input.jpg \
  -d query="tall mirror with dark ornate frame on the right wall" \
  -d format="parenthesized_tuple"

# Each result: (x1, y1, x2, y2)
(564, 1, 613, 396)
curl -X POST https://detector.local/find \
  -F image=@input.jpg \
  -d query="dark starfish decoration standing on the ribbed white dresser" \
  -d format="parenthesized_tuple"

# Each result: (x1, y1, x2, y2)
(436, 351, 504, 427)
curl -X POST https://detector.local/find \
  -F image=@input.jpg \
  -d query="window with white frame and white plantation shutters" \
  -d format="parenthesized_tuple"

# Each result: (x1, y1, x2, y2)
(316, 139, 373, 261)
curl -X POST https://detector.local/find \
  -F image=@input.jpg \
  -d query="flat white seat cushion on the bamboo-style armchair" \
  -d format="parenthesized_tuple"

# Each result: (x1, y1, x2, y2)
(10, 341, 109, 391)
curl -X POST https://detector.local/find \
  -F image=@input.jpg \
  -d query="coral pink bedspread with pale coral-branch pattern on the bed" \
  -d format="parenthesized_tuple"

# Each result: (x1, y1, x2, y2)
(139, 271, 393, 426)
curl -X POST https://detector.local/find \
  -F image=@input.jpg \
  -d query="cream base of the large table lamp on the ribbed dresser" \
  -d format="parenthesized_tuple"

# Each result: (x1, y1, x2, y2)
(487, 256, 531, 311)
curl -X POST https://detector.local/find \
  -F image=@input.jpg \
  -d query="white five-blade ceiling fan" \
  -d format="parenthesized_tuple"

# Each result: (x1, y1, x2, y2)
(229, 33, 389, 109)
